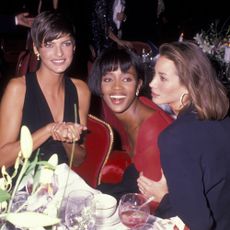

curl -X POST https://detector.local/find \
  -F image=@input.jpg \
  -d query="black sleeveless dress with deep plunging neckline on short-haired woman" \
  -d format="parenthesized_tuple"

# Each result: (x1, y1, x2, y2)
(22, 73, 79, 164)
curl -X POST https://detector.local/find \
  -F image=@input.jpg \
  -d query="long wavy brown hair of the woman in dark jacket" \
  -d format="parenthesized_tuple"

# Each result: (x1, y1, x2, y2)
(159, 41, 229, 120)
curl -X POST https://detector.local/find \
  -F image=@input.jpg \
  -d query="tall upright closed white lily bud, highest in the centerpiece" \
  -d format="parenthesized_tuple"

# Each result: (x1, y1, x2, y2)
(20, 125, 33, 159)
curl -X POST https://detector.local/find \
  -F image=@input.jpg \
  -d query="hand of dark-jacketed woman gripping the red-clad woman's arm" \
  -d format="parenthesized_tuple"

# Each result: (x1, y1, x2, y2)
(137, 171, 168, 202)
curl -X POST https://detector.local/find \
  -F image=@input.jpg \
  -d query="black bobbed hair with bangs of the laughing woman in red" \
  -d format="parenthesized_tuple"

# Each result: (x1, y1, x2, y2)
(88, 48, 145, 96)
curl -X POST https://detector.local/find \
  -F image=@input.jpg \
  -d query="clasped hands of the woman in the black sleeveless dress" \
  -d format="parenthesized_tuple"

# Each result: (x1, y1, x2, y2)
(50, 122, 87, 143)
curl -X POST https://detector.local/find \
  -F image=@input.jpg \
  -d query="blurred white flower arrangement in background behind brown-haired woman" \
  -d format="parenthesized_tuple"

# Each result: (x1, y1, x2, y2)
(194, 21, 230, 80)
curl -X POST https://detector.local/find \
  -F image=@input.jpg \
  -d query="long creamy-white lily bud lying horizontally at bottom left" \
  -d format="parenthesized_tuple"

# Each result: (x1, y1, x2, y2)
(6, 212, 60, 228)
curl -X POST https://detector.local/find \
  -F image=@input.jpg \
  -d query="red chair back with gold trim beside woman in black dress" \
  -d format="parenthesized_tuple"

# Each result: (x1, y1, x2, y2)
(73, 114, 114, 188)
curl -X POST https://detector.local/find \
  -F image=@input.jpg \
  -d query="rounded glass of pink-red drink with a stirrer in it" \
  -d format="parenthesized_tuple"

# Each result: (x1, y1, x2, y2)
(118, 193, 150, 228)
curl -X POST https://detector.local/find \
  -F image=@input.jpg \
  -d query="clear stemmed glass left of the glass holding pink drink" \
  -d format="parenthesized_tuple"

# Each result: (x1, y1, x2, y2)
(65, 190, 96, 230)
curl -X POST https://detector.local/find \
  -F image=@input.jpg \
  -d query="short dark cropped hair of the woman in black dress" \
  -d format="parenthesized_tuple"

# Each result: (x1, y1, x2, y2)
(31, 10, 75, 48)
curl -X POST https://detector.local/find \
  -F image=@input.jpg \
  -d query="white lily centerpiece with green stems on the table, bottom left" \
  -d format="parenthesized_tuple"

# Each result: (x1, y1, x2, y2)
(0, 126, 60, 229)
